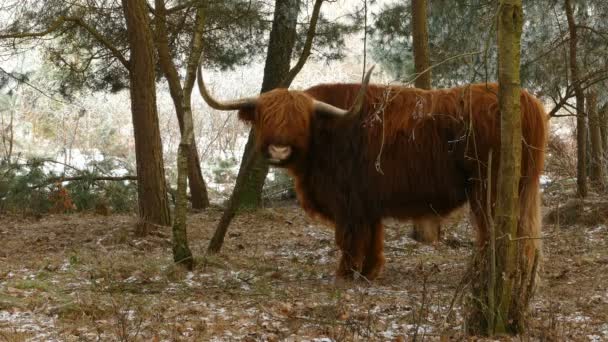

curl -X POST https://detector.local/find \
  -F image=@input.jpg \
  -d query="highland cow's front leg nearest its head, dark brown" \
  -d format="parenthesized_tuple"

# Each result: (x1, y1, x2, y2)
(336, 227, 371, 279)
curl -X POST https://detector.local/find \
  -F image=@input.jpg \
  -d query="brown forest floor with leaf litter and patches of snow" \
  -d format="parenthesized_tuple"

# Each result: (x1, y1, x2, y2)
(0, 194, 608, 341)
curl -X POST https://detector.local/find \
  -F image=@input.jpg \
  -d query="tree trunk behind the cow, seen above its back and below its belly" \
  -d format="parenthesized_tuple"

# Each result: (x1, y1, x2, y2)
(411, 0, 441, 243)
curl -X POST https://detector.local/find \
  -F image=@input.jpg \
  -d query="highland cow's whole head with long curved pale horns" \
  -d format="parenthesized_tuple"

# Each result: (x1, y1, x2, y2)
(197, 64, 374, 166)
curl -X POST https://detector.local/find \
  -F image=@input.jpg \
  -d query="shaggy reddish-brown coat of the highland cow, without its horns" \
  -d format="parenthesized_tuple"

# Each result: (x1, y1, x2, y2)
(240, 84, 547, 279)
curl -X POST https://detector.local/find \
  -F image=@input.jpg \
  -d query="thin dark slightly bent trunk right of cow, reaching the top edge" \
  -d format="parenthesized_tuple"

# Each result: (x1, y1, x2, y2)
(564, 0, 587, 197)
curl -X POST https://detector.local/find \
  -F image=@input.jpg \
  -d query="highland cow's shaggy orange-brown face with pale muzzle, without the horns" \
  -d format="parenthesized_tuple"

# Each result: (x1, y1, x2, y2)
(239, 89, 314, 166)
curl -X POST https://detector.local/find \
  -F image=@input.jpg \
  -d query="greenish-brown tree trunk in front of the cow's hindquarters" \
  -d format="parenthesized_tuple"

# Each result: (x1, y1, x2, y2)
(493, 0, 523, 333)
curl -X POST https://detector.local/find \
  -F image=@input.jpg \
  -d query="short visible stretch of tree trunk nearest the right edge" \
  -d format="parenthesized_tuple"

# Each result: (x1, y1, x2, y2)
(587, 89, 606, 192)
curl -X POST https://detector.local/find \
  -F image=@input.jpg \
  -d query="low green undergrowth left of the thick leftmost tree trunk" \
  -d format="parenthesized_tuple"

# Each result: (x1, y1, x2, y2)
(0, 158, 137, 216)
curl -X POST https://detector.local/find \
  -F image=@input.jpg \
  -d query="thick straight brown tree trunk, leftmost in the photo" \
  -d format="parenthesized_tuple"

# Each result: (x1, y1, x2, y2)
(122, 0, 171, 234)
